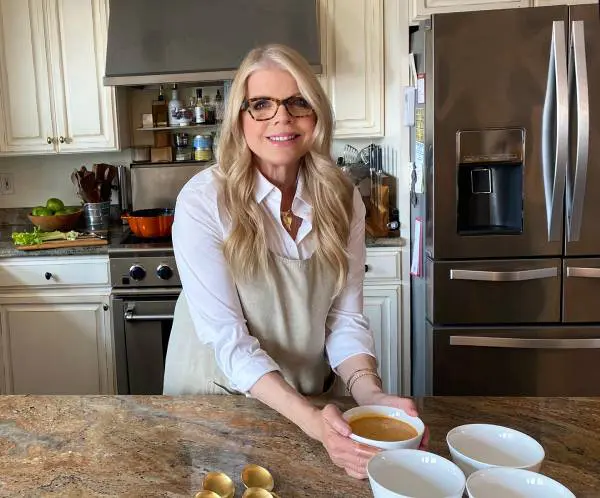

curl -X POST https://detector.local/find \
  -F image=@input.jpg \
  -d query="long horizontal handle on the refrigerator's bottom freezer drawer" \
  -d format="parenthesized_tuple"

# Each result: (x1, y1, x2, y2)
(450, 335, 600, 349)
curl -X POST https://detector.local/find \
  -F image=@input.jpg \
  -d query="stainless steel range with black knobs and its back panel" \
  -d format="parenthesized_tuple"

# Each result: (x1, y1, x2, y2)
(109, 164, 205, 394)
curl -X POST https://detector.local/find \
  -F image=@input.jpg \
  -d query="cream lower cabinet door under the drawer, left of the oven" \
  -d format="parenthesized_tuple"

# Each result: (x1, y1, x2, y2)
(1, 298, 113, 395)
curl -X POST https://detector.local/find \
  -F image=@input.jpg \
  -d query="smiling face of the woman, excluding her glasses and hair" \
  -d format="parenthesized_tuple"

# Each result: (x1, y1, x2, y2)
(242, 68, 316, 170)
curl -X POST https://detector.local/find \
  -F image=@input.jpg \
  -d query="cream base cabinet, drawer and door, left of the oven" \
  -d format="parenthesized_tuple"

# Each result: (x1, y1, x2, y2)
(0, 256, 115, 395)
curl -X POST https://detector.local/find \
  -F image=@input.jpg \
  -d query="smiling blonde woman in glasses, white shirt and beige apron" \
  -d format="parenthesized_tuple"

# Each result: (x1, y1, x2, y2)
(164, 45, 416, 478)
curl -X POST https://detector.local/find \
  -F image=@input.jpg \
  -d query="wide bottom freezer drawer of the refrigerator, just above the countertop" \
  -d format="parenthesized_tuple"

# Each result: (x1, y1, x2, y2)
(429, 326, 600, 396)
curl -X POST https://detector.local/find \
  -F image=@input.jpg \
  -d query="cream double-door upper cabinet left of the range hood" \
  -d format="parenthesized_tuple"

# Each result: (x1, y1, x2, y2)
(0, 0, 121, 155)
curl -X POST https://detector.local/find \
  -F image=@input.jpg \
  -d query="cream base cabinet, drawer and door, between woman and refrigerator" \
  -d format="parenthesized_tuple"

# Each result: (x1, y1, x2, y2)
(363, 247, 410, 395)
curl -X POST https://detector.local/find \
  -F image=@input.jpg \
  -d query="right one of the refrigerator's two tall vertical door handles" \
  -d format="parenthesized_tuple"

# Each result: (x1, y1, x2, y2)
(567, 21, 590, 242)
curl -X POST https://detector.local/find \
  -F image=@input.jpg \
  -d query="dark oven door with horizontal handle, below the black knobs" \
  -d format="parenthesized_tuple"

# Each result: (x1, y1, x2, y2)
(112, 290, 180, 394)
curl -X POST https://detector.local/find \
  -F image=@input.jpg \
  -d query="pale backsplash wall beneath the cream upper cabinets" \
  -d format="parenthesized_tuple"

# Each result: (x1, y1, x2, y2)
(0, 140, 378, 209)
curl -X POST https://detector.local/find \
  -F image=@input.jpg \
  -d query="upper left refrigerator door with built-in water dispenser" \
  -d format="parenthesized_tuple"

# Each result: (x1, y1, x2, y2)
(425, 7, 569, 260)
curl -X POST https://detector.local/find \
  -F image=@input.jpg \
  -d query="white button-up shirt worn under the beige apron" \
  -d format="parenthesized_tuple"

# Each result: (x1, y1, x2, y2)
(172, 166, 375, 392)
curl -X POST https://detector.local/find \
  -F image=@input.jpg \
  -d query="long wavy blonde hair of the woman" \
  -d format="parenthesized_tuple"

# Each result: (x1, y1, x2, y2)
(217, 45, 353, 294)
